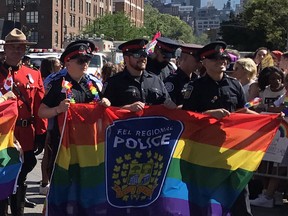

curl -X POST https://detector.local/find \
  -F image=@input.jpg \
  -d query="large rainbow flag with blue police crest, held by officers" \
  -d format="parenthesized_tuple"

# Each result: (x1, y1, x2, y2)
(46, 104, 280, 216)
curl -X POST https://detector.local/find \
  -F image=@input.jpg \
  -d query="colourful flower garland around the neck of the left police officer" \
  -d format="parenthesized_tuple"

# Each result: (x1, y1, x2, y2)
(61, 77, 100, 103)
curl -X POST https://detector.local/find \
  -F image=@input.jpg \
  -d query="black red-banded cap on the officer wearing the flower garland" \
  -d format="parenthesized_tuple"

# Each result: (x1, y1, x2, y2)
(60, 40, 95, 63)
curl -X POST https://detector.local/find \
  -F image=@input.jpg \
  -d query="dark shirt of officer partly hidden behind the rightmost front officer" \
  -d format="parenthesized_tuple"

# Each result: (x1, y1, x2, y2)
(164, 67, 198, 105)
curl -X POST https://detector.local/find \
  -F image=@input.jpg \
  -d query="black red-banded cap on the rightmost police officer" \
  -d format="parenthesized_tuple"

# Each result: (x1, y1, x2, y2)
(199, 41, 230, 59)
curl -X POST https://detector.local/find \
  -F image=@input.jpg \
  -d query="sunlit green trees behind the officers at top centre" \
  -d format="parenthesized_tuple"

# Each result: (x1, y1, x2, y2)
(83, 4, 207, 44)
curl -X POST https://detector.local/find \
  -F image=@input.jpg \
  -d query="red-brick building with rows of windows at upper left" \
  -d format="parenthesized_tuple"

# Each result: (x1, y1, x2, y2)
(0, 0, 112, 49)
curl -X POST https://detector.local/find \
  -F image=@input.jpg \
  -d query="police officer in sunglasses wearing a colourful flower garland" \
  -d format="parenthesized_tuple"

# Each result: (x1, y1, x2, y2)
(38, 40, 110, 187)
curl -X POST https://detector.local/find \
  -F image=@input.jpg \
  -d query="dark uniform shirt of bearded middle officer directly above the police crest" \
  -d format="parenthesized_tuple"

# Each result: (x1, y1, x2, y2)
(102, 68, 170, 107)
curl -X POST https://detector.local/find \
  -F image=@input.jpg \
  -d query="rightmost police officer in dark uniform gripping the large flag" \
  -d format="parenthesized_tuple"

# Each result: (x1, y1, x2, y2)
(183, 41, 257, 216)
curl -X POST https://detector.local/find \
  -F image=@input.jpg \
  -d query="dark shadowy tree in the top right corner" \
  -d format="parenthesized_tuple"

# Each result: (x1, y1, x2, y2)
(221, 0, 288, 51)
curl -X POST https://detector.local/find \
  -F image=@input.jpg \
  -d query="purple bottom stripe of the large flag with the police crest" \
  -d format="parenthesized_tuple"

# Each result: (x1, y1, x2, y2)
(48, 195, 230, 216)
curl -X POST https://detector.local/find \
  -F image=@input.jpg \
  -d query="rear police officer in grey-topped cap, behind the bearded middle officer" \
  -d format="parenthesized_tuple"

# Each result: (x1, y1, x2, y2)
(146, 37, 180, 80)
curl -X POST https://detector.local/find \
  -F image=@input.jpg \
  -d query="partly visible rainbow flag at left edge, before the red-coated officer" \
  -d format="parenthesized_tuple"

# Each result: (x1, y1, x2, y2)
(0, 100, 21, 200)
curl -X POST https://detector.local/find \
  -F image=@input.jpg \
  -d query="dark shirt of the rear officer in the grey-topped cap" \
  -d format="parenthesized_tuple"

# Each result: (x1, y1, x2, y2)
(146, 56, 175, 80)
